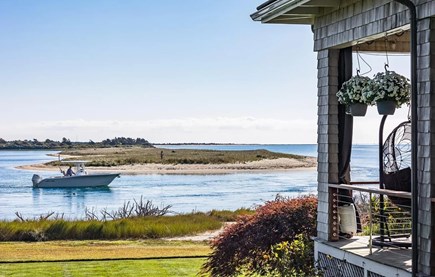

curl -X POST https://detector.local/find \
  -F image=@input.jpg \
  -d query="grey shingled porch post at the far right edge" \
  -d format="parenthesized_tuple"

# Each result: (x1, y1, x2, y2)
(413, 17, 435, 276)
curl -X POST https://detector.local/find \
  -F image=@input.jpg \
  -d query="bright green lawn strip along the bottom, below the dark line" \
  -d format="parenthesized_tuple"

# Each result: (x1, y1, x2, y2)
(0, 258, 205, 277)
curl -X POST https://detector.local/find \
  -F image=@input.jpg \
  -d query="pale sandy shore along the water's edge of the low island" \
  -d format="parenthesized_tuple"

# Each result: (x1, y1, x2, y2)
(17, 157, 317, 175)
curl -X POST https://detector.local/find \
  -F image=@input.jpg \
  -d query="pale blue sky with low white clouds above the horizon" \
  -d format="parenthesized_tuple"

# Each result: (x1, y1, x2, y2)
(0, 0, 409, 143)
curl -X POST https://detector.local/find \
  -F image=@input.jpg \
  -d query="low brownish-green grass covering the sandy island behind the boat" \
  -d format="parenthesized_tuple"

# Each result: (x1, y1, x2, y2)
(48, 147, 305, 167)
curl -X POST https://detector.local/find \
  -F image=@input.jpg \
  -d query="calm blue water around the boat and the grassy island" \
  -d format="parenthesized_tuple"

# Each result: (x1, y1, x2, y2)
(0, 145, 377, 219)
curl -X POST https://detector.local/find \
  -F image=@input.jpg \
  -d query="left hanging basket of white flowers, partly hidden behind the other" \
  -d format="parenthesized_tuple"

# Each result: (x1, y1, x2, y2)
(337, 75, 370, 116)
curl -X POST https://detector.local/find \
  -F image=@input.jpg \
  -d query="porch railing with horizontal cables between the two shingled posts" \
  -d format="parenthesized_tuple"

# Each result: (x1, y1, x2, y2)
(329, 182, 412, 254)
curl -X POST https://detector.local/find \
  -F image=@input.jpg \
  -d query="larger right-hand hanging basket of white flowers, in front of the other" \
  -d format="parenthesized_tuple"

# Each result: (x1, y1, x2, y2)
(362, 70, 411, 115)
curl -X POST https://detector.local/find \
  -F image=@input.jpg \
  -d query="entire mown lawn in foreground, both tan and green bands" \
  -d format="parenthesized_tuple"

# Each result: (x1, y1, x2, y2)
(0, 240, 210, 277)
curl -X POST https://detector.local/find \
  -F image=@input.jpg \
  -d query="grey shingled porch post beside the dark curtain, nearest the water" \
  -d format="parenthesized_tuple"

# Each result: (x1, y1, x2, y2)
(317, 49, 339, 241)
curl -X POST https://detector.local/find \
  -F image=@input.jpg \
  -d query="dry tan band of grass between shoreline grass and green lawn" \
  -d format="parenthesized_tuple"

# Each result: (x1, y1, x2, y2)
(0, 240, 210, 262)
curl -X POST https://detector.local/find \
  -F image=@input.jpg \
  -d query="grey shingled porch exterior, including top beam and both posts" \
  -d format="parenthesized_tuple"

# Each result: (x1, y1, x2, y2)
(313, 0, 435, 275)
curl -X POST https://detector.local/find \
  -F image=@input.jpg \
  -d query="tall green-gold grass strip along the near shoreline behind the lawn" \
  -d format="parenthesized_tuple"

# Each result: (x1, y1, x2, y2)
(0, 213, 222, 241)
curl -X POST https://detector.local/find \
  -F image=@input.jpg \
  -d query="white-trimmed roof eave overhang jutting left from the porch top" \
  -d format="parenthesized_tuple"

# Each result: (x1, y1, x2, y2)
(251, 0, 340, 25)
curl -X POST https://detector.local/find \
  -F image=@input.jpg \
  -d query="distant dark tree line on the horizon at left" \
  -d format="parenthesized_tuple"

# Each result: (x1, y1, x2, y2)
(0, 137, 154, 150)
